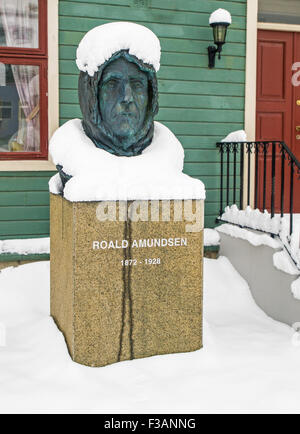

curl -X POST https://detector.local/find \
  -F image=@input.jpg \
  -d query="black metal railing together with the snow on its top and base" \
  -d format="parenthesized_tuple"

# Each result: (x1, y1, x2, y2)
(217, 131, 300, 270)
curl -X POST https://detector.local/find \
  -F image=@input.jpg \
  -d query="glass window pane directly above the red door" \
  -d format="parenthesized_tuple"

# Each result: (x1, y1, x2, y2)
(258, 0, 300, 24)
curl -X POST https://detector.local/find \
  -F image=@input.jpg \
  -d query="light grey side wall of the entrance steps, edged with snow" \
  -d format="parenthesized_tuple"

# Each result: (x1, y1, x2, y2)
(218, 224, 300, 325)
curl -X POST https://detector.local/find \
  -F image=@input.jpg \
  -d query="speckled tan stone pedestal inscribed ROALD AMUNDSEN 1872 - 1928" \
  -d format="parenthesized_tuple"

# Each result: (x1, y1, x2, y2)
(51, 195, 203, 367)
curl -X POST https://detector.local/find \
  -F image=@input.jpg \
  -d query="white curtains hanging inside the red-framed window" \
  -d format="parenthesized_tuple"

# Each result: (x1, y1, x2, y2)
(0, 0, 40, 152)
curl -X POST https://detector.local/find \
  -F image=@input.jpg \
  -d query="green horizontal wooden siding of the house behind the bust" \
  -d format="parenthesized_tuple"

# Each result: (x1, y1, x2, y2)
(0, 0, 247, 239)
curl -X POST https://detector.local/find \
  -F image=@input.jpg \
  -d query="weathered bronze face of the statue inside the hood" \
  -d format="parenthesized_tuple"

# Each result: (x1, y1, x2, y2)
(99, 58, 148, 139)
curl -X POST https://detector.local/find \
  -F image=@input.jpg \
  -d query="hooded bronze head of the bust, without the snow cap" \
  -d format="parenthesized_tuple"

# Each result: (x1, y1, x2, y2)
(79, 50, 158, 157)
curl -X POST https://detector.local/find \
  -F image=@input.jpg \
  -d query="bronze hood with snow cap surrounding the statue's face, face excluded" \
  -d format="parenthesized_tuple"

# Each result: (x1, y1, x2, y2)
(76, 22, 160, 157)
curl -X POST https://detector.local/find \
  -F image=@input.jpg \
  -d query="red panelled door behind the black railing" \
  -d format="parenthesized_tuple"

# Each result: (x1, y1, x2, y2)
(256, 30, 300, 212)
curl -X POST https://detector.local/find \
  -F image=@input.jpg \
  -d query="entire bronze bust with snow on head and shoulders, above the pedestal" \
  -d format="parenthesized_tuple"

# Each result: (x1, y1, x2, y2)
(49, 22, 204, 202)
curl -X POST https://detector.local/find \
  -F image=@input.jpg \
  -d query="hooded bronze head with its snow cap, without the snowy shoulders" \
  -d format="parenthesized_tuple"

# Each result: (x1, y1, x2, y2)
(57, 23, 160, 187)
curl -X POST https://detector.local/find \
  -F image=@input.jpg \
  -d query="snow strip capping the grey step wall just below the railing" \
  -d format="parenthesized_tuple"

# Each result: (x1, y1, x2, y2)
(216, 223, 282, 249)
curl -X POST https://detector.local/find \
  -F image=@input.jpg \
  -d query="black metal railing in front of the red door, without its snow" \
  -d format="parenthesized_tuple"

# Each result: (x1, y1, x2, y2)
(217, 141, 300, 235)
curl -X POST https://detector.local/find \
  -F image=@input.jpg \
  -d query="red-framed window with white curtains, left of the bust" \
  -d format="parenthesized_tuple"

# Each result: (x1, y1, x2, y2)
(0, 0, 48, 160)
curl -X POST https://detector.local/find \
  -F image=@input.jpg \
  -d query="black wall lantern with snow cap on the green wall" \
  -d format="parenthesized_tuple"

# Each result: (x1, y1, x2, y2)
(208, 9, 232, 68)
